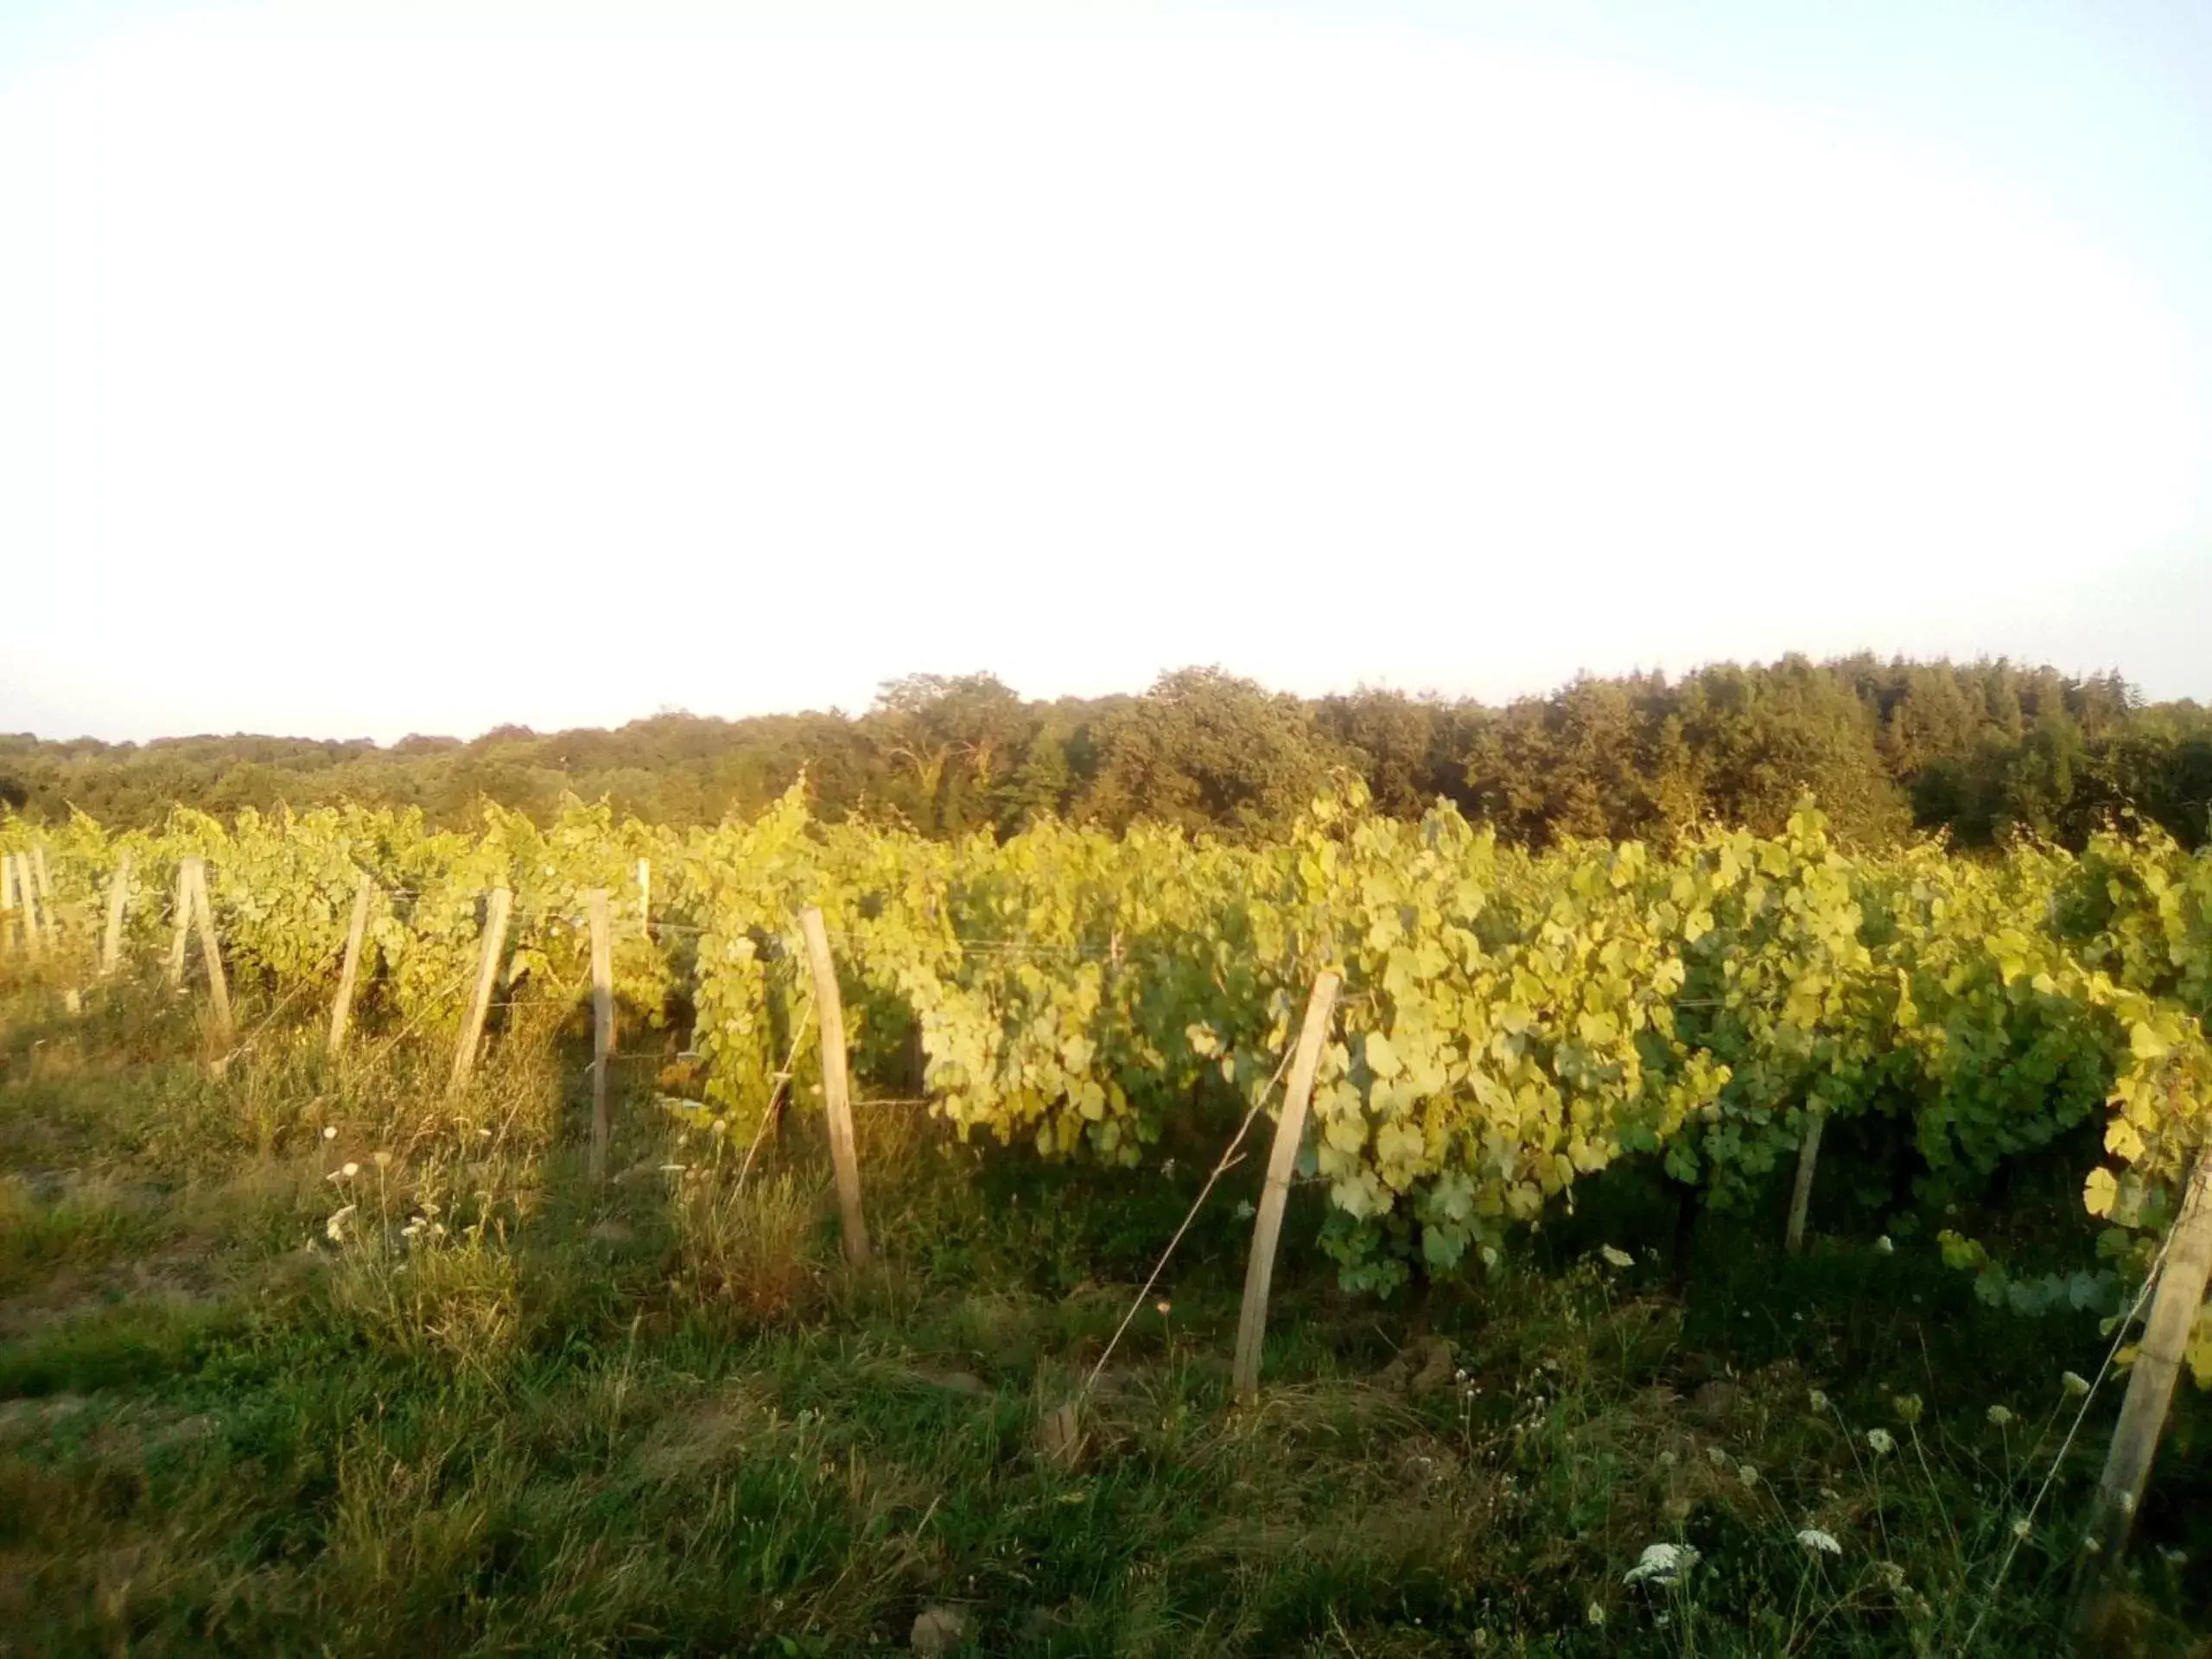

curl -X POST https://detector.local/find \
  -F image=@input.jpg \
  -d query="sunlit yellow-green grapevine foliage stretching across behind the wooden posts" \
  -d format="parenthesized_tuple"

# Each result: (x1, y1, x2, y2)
(0, 785, 2212, 1370)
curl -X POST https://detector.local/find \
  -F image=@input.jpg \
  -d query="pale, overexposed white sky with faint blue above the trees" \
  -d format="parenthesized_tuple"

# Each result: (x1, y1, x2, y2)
(0, 0, 2212, 739)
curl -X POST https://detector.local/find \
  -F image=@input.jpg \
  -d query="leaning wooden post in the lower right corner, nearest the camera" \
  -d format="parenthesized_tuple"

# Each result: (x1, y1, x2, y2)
(2073, 1146, 2212, 1635)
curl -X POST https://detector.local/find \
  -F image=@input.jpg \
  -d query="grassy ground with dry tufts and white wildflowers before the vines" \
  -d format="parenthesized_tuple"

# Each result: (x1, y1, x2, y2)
(0, 982, 2212, 1659)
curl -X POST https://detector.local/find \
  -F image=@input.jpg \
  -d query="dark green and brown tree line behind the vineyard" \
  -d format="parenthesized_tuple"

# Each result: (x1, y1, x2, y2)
(0, 655, 2212, 847)
